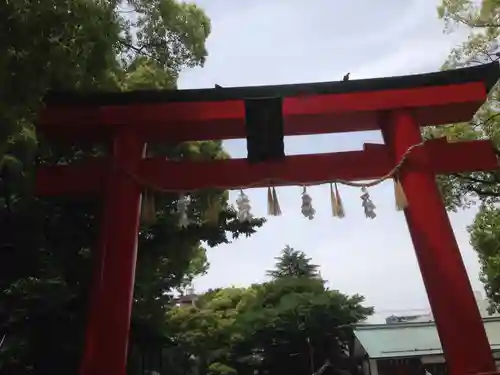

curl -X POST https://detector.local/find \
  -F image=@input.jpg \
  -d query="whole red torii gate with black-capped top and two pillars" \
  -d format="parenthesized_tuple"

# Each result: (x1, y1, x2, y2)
(36, 63, 500, 375)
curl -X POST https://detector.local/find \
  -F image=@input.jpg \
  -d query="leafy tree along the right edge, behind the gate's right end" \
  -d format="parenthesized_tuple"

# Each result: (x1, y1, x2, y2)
(432, 0, 500, 311)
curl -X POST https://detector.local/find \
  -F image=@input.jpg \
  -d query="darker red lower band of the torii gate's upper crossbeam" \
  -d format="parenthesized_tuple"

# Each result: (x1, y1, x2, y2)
(35, 102, 482, 143)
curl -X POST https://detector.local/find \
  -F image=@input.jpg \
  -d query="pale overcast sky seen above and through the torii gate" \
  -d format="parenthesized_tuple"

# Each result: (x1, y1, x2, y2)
(179, 0, 482, 319)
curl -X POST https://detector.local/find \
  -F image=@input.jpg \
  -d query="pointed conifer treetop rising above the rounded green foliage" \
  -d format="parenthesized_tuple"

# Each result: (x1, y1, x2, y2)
(267, 245, 319, 279)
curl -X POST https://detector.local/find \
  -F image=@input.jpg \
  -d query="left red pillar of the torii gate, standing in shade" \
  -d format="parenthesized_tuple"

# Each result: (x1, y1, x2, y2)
(80, 128, 145, 375)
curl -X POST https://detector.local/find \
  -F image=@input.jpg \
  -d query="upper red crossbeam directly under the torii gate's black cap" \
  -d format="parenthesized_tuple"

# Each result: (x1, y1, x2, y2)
(37, 83, 486, 142)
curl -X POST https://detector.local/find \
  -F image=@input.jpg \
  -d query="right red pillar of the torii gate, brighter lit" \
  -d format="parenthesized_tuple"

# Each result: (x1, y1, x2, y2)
(383, 112, 495, 375)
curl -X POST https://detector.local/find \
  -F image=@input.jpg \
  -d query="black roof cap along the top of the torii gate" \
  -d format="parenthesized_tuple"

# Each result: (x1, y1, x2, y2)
(45, 62, 500, 106)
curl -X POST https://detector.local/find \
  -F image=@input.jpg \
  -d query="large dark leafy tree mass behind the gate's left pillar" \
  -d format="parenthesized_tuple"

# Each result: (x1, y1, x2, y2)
(0, 0, 263, 374)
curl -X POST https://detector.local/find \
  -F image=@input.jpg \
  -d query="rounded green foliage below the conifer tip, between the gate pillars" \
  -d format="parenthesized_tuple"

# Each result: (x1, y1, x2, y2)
(168, 253, 373, 375)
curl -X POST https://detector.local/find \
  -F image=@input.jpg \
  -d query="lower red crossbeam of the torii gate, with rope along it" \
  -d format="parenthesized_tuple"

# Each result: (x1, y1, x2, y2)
(36, 139, 498, 195)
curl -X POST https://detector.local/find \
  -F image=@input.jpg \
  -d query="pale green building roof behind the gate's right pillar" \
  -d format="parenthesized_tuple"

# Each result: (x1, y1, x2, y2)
(354, 317, 500, 359)
